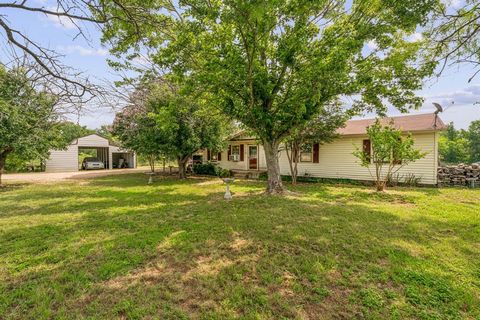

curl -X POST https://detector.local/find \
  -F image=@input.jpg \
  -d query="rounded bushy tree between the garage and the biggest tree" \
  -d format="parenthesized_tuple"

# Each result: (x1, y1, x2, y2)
(113, 78, 231, 177)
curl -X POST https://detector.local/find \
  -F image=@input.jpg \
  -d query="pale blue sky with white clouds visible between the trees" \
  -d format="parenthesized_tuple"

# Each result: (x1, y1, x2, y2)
(0, 0, 480, 129)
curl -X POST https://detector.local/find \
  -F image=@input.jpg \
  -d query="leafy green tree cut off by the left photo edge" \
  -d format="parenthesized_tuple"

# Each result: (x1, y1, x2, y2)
(0, 65, 65, 186)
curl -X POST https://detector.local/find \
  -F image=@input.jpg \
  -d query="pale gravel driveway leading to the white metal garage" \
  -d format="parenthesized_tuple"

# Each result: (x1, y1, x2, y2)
(2, 168, 148, 182)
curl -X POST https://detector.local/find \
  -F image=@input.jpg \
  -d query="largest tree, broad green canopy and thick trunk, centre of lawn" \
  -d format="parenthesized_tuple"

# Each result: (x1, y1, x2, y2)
(104, 0, 437, 193)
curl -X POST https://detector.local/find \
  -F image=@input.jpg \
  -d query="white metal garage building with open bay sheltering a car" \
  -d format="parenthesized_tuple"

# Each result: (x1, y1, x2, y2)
(45, 134, 137, 172)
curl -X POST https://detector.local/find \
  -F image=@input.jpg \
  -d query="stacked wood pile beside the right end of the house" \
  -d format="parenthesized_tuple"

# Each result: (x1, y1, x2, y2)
(438, 163, 480, 187)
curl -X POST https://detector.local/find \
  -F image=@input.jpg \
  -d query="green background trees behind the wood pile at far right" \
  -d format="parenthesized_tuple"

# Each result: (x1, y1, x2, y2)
(439, 120, 480, 164)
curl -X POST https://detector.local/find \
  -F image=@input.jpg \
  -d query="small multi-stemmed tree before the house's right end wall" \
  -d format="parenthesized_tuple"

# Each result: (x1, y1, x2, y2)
(353, 119, 426, 191)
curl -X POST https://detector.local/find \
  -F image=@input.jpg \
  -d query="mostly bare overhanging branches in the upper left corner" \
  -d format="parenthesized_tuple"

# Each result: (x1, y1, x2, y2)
(0, 0, 166, 107)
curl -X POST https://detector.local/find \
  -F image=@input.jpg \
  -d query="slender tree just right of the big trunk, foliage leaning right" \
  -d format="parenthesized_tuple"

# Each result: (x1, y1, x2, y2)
(284, 104, 348, 184)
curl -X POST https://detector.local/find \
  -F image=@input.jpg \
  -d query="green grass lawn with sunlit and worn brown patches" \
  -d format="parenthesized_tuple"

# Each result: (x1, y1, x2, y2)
(0, 174, 480, 319)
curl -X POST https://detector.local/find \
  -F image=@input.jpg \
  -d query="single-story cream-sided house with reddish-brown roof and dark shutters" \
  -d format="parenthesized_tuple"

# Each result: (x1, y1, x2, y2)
(202, 113, 446, 185)
